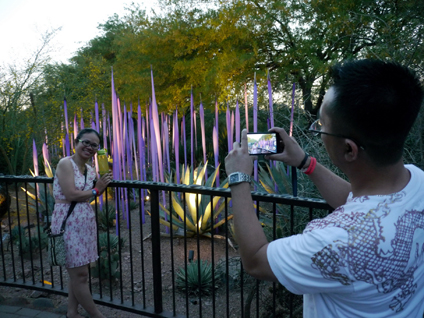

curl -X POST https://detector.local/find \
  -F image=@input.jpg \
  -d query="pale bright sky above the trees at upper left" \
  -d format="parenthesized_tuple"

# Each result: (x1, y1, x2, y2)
(0, 0, 156, 65)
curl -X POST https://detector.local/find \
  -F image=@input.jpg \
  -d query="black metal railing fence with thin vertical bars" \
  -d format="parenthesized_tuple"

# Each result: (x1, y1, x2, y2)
(0, 176, 331, 317)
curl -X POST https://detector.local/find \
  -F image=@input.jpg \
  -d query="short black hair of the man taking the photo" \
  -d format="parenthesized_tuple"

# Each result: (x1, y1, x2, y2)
(327, 59, 423, 165)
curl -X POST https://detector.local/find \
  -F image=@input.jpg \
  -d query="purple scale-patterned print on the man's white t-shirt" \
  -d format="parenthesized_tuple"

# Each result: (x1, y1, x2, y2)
(304, 192, 424, 312)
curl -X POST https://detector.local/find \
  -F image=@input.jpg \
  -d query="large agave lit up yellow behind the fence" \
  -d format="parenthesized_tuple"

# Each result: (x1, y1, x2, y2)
(160, 162, 233, 237)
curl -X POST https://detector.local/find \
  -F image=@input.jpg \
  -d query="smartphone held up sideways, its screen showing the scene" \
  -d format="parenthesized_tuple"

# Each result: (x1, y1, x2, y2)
(247, 132, 283, 156)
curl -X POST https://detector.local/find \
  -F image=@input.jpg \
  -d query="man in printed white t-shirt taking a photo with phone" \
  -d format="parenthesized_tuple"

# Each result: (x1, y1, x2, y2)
(225, 60, 424, 317)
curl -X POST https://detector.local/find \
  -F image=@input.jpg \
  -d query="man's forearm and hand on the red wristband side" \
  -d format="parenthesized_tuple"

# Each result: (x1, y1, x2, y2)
(266, 127, 351, 208)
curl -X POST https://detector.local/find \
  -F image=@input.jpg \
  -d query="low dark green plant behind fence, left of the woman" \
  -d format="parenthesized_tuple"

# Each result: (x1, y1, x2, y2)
(10, 226, 47, 256)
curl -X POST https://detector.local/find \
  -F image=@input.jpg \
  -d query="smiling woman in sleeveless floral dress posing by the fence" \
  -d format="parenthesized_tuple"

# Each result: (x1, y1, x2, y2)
(52, 128, 112, 318)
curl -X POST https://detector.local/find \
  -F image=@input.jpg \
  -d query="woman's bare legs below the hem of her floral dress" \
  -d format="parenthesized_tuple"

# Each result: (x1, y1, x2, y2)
(67, 265, 105, 318)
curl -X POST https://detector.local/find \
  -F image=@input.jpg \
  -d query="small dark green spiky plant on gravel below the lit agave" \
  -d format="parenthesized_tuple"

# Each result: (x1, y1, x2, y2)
(177, 260, 220, 295)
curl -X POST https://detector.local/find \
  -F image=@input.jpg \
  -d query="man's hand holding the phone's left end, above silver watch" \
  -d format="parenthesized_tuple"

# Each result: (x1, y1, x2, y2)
(225, 129, 256, 176)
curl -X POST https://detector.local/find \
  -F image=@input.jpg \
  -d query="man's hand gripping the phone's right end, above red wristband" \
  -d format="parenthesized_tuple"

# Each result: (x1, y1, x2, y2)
(265, 127, 307, 167)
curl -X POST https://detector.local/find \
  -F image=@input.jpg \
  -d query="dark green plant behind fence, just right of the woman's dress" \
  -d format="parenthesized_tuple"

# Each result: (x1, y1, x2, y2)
(91, 233, 124, 280)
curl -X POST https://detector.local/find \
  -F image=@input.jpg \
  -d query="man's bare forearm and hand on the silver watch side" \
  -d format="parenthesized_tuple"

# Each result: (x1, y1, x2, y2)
(225, 130, 278, 282)
